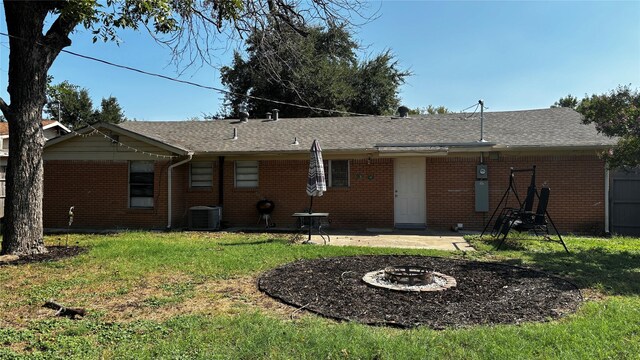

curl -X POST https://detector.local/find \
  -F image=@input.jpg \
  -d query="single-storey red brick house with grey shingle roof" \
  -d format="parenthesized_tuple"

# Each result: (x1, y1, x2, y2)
(44, 108, 613, 232)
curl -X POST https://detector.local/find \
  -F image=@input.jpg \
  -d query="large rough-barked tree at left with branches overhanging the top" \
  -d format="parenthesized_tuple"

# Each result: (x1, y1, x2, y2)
(0, 0, 361, 255)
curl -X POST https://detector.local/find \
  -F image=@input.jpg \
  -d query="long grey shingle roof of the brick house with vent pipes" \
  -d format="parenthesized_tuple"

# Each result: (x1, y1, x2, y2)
(118, 108, 615, 154)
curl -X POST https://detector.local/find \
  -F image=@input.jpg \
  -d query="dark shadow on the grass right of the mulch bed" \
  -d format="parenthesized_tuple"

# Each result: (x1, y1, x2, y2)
(480, 238, 640, 295)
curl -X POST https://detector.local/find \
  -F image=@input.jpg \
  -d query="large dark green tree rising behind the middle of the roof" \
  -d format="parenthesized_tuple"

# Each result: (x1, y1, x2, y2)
(221, 24, 410, 117)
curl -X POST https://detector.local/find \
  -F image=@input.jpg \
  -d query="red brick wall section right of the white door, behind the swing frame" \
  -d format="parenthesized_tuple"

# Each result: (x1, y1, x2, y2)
(427, 156, 605, 232)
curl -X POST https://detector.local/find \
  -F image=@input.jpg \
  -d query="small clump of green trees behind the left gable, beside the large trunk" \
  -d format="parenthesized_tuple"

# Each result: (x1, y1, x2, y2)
(44, 80, 127, 129)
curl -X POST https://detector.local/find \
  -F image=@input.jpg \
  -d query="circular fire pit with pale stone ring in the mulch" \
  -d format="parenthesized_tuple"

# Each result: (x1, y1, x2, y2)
(362, 265, 457, 291)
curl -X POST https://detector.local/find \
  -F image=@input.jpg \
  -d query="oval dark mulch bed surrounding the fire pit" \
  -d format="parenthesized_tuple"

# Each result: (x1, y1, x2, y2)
(258, 255, 582, 329)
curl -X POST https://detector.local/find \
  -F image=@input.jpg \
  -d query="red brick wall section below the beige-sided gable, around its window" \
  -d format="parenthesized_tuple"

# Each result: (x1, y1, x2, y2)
(43, 160, 169, 229)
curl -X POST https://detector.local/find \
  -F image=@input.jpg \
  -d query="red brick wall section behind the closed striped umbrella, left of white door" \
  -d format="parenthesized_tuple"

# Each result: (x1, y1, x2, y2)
(223, 159, 393, 228)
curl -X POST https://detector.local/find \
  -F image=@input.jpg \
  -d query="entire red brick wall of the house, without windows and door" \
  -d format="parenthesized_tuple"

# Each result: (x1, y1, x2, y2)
(44, 155, 604, 232)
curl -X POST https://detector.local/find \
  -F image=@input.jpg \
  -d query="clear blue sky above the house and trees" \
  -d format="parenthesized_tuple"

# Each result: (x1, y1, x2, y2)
(0, 1, 640, 120)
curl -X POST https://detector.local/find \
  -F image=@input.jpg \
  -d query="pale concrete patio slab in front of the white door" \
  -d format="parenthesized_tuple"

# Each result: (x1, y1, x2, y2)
(302, 229, 475, 251)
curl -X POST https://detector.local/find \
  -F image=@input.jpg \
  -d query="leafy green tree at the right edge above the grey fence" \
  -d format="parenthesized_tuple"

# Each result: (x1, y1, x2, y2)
(576, 86, 640, 169)
